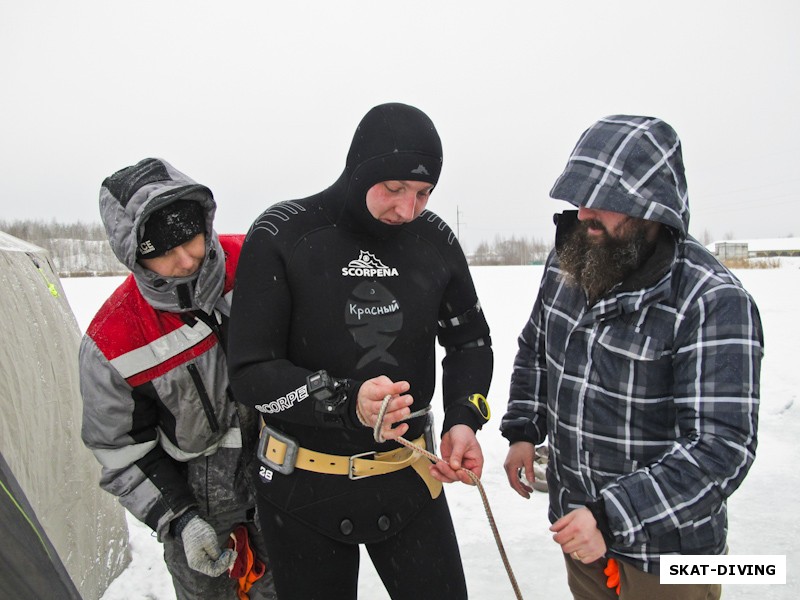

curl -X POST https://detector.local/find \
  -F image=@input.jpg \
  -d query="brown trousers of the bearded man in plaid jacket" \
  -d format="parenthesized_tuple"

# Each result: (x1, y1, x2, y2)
(564, 554, 722, 600)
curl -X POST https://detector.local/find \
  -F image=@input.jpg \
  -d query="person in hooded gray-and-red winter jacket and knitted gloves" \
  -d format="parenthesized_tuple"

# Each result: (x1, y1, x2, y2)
(80, 158, 275, 600)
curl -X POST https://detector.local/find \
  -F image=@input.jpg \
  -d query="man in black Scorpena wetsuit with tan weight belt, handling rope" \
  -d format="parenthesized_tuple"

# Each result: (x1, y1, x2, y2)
(229, 104, 492, 600)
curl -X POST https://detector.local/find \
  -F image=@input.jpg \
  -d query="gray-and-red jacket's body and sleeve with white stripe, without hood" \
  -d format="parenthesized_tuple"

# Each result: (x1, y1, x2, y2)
(80, 234, 243, 535)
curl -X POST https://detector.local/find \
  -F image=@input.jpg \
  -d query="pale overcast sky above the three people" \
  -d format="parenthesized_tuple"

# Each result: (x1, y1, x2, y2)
(0, 0, 800, 249)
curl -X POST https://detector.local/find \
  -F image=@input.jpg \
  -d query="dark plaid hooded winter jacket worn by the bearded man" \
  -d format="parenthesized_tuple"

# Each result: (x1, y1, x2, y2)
(501, 115, 763, 573)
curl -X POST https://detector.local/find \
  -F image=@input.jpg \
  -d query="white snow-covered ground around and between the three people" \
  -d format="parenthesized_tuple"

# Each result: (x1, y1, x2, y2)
(62, 259, 800, 600)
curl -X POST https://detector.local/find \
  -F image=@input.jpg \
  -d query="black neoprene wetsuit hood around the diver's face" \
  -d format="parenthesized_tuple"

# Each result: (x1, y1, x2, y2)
(326, 103, 442, 238)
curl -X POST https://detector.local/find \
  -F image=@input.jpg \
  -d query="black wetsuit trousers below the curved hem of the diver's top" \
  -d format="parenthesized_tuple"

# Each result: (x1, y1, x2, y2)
(258, 494, 467, 600)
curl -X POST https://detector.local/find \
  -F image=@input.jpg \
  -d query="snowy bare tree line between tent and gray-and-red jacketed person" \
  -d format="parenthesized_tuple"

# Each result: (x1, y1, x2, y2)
(0, 219, 128, 277)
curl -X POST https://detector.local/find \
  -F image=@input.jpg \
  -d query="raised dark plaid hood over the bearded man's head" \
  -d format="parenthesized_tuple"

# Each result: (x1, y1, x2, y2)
(550, 115, 689, 239)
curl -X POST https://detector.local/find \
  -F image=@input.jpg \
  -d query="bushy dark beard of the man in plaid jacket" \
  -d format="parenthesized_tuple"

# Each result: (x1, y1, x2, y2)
(558, 219, 656, 306)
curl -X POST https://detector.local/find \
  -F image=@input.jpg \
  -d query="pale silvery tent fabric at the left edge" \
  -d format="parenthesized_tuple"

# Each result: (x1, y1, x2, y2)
(0, 232, 130, 600)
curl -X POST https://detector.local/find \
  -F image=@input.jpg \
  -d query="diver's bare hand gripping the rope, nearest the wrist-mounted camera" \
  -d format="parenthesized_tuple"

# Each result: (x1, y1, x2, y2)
(356, 375, 414, 440)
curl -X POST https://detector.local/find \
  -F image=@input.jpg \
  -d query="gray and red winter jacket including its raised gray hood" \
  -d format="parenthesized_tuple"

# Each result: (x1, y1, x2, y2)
(80, 159, 243, 538)
